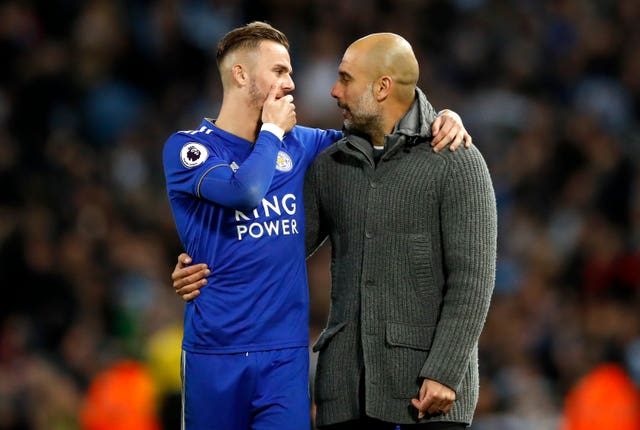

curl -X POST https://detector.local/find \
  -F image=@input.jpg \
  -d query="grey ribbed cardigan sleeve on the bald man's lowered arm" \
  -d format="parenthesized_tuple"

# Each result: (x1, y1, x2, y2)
(420, 151, 497, 389)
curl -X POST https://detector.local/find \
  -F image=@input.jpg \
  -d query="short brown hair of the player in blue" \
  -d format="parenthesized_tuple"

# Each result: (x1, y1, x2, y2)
(216, 21, 289, 67)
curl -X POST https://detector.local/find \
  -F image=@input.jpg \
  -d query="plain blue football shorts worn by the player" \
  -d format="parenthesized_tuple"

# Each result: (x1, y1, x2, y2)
(182, 348, 311, 430)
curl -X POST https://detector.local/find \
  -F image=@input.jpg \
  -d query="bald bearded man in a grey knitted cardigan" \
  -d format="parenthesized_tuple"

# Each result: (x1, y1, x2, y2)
(305, 33, 497, 430)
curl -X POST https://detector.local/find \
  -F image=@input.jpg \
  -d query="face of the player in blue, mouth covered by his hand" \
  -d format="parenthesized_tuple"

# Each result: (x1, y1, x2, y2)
(249, 41, 295, 108)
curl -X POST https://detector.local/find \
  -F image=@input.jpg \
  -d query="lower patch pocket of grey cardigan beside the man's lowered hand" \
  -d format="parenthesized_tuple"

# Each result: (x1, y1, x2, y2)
(383, 322, 435, 399)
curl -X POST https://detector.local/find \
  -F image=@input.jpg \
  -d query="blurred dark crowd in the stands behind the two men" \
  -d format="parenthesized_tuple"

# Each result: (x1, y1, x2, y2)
(0, 0, 640, 430)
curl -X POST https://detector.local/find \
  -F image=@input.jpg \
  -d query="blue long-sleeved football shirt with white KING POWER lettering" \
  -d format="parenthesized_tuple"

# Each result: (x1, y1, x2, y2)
(163, 119, 342, 353)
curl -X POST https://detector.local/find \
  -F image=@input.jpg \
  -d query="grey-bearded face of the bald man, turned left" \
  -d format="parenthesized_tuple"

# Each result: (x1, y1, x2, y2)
(331, 50, 382, 134)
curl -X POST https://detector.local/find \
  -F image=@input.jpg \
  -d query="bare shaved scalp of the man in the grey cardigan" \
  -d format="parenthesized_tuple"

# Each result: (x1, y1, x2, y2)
(343, 33, 419, 101)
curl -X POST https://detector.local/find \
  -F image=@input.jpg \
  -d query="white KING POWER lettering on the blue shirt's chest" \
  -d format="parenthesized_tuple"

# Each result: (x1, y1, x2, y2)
(235, 194, 300, 240)
